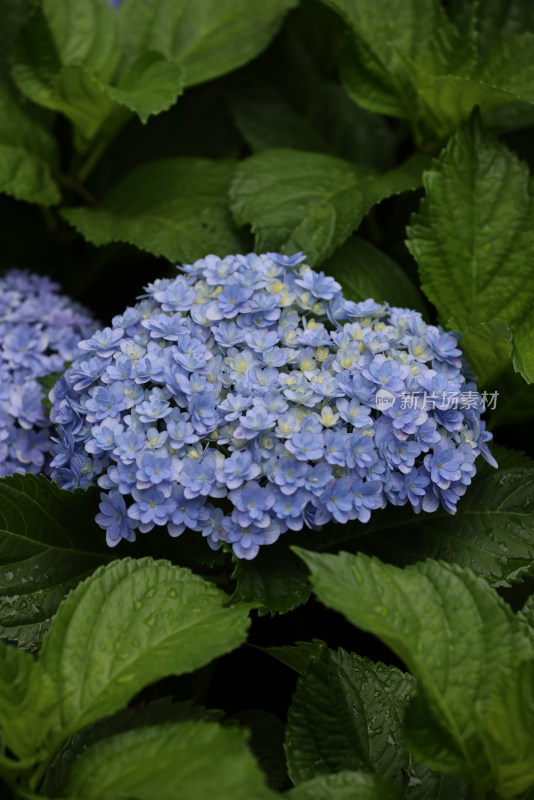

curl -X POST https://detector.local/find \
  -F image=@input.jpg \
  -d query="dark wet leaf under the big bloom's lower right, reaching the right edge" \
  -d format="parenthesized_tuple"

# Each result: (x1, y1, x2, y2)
(314, 446, 534, 586)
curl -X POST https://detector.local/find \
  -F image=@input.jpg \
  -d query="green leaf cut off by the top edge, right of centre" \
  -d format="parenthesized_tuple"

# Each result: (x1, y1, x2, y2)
(332, 0, 476, 135)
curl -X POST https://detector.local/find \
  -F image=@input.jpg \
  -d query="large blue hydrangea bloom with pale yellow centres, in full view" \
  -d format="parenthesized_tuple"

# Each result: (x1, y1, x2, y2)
(51, 253, 495, 559)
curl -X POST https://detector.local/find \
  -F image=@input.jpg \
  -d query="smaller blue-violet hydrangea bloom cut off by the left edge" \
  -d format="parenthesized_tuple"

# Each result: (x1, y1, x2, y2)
(0, 270, 96, 477)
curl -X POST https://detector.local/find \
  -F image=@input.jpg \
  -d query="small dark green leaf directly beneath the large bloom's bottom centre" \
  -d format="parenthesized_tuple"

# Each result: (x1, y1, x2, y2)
(232, 542, 311, 615)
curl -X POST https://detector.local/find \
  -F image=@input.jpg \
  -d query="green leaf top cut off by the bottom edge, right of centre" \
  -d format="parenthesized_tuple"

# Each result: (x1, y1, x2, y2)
(287, 772, 404, 800)
